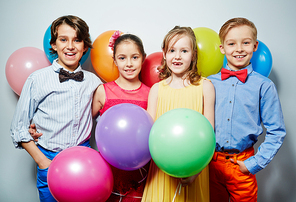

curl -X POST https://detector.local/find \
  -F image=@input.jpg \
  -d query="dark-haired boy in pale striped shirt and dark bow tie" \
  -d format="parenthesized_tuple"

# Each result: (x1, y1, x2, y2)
(10, 16, 101, 201)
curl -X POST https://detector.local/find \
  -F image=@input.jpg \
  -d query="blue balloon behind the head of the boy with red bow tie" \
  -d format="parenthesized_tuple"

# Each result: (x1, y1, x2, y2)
(223, 40, 272, 77)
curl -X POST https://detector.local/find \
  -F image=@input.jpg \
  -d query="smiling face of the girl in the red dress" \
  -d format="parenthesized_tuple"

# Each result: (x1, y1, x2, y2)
(114, 41, 144, 81)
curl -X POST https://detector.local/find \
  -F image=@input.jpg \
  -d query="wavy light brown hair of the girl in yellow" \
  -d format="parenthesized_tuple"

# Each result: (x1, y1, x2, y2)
(158, 26, 201, 85)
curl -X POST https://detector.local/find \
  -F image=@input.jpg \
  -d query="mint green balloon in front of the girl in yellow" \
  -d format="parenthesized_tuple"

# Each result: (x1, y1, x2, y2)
(149, 108, 216, 178)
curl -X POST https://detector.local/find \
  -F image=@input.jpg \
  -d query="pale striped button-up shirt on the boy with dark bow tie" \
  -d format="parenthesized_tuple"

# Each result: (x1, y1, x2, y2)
(10, 60, 102, 152)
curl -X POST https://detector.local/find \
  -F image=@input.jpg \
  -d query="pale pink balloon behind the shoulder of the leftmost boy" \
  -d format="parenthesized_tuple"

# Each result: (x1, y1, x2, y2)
(5, 47, 51, 95)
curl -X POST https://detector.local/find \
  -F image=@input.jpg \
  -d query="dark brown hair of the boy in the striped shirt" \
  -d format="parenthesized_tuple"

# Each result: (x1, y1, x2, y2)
(49, 15, 92, 55)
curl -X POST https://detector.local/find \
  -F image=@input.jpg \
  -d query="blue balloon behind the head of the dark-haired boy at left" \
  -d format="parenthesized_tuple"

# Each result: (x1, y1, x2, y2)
(43, 25, 90, 64)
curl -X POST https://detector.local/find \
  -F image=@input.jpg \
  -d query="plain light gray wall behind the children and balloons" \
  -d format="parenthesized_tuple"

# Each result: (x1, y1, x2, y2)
(0, 0, 296, 202)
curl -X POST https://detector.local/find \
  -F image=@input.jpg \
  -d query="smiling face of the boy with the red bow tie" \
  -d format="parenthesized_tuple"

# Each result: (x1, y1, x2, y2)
(220, 25, 258, 70)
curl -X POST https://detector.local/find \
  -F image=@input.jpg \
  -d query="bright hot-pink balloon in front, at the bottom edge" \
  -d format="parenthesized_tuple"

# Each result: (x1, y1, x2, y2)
(47, 146, 113, 202)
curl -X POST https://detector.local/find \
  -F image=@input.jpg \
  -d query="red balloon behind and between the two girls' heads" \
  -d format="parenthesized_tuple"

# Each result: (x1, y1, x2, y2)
(140, 52, 163, 87)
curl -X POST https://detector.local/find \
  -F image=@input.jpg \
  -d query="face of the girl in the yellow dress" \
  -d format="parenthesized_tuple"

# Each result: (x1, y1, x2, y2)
(164, 35, 193, 77)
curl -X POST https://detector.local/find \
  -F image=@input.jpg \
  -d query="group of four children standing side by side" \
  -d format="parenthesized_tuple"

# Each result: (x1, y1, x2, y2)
(11, 16, 286, 202)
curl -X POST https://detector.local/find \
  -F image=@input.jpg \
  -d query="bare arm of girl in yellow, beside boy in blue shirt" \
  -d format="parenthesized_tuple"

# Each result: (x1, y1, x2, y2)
(203, 80, 215, 128)
